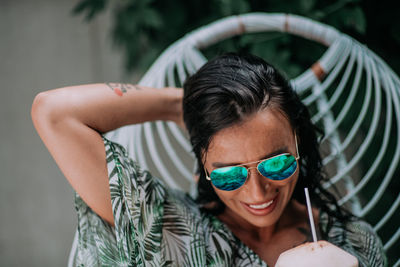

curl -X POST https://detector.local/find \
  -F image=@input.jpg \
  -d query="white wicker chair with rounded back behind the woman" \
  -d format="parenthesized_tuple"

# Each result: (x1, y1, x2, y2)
(70, 13, 400, 266)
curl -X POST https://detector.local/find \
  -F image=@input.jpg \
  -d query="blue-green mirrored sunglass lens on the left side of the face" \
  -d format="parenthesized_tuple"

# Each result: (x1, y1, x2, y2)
(210, 166, 247, 191)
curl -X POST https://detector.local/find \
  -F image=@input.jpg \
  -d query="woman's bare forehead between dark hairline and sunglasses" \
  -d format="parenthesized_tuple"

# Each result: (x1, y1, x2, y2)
(204, 109, 294, 164)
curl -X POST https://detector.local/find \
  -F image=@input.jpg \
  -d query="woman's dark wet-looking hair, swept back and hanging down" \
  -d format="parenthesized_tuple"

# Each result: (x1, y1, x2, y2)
(183, 53, 350, 239)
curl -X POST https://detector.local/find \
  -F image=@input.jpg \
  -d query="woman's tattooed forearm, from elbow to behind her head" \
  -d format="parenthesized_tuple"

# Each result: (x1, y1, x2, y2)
(33, 83, 182, 133)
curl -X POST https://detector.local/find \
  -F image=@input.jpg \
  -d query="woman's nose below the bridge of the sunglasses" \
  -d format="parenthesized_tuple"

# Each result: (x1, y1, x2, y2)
(245, 167, 269, 202)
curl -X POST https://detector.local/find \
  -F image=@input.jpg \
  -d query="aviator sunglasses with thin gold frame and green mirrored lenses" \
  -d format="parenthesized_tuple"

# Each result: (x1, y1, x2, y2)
(204, 135, 300, 191)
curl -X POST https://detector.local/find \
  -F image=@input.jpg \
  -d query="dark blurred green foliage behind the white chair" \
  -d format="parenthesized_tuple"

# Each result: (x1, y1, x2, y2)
(73, 0, 400, 265)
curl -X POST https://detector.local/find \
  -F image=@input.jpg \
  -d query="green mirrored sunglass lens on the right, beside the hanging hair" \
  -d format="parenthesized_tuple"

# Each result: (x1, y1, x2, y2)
(257, 154, 297, 180)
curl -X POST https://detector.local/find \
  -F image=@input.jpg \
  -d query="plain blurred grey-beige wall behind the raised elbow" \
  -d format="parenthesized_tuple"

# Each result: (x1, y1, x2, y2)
(0, 0, 134, 266)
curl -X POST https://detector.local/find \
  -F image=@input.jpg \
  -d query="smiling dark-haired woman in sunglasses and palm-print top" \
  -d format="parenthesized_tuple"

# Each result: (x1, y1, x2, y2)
(32, 54, 385, 266)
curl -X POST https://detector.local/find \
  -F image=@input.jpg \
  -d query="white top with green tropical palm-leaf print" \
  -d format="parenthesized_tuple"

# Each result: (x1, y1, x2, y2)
(73, 137, 386, 267)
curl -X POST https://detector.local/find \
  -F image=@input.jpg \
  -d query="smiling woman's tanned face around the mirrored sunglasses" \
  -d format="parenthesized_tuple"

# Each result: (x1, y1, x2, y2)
(204, 109, 299, 230)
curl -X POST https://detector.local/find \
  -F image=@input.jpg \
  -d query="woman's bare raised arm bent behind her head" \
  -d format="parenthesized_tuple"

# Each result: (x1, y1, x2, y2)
(31, 83, 183, 225)
